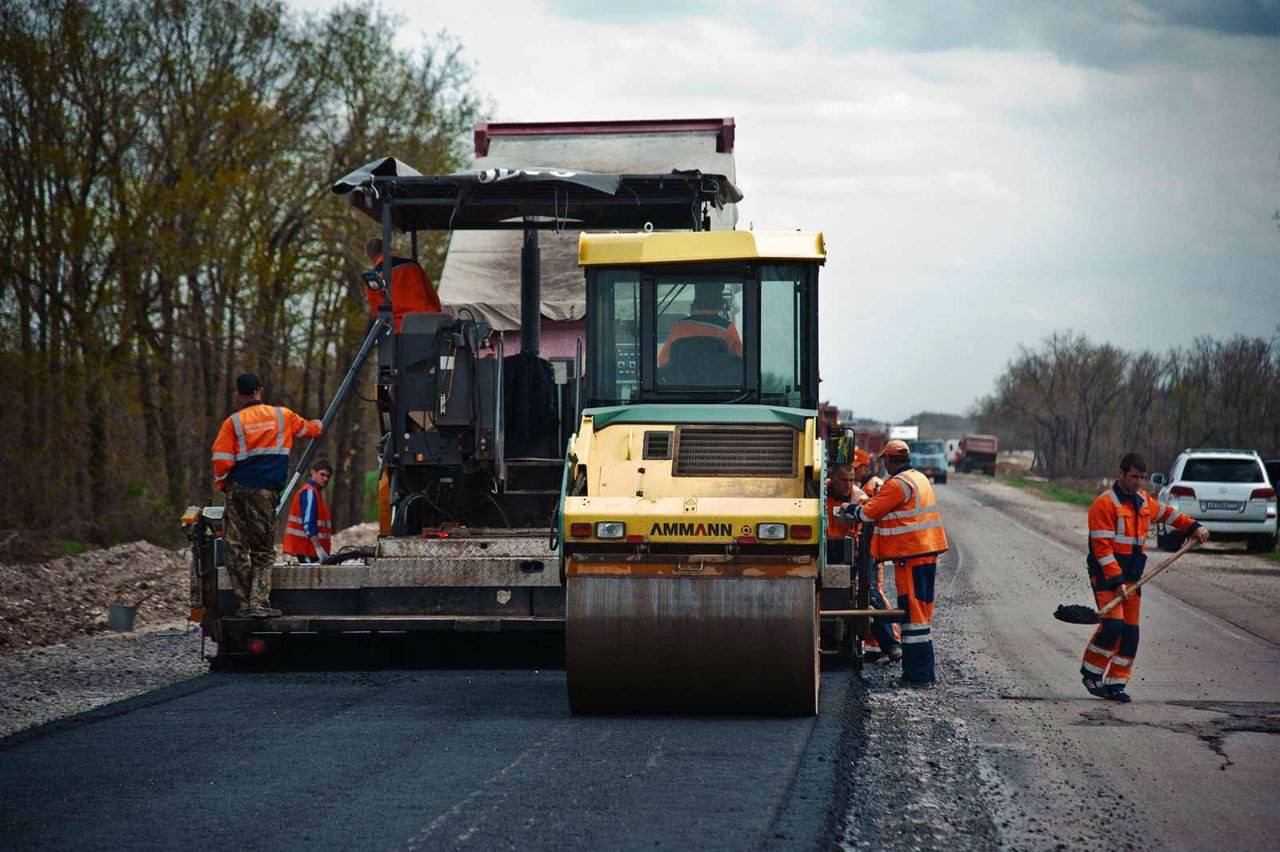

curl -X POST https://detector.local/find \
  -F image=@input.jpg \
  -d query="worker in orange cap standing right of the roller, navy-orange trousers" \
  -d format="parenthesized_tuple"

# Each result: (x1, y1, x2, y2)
(845, 440, 947, 686)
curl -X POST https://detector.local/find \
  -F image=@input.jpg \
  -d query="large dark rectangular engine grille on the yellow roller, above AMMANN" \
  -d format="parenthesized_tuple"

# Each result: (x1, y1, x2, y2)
(672, 426, 796, 477)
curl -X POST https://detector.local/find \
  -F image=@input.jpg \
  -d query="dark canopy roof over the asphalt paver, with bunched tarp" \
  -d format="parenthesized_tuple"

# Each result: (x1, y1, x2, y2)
(333, 157, 742, 230)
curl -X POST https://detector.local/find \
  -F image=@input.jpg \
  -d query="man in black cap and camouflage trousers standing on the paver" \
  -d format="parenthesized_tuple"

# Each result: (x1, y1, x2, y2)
(212, 372, 323, 618)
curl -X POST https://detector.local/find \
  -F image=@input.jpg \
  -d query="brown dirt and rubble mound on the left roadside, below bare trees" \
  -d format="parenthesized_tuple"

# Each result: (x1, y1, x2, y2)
(0, 541, 189, 654)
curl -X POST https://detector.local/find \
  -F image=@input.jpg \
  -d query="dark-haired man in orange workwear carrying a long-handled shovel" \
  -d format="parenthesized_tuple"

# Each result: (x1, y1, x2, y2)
(1080, 453, 1208, 704)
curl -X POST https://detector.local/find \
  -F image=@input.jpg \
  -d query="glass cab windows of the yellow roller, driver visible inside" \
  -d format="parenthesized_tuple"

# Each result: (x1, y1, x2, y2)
(586, 262, 818, 408)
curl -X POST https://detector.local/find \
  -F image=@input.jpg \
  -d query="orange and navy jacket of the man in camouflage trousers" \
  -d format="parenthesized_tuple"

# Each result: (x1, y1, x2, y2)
(212, 402, 321, 491)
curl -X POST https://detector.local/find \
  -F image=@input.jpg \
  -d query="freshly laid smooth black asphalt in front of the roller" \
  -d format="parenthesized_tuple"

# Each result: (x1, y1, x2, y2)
(0, 670, 850, 849)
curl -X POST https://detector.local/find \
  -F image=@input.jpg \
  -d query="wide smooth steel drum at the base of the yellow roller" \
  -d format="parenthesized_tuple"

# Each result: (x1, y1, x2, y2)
(564, 576, 818, 715)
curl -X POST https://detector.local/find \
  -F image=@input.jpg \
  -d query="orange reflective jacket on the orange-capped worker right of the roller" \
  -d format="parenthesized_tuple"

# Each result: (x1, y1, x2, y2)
(861, 468, 947, 562)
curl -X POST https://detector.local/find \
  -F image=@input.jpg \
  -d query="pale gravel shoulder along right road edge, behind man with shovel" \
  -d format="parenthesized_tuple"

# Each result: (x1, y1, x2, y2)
(952, 473, 1280, 642)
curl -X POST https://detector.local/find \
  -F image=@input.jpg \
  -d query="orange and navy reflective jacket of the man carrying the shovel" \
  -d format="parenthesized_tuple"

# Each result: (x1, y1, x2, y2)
(1087, 485, 1199, 590)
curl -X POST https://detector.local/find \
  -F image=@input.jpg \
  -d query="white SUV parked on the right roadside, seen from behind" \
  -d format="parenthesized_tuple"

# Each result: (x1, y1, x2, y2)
(1151, 449, 1276, 553)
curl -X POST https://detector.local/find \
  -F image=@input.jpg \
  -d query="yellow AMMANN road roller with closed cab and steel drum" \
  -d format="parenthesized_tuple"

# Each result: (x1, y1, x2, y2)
(554, 230, 829, 715)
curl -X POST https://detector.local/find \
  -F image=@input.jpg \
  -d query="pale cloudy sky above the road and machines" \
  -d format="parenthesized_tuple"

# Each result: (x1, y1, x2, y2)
(294, 0, 1280, 418)
